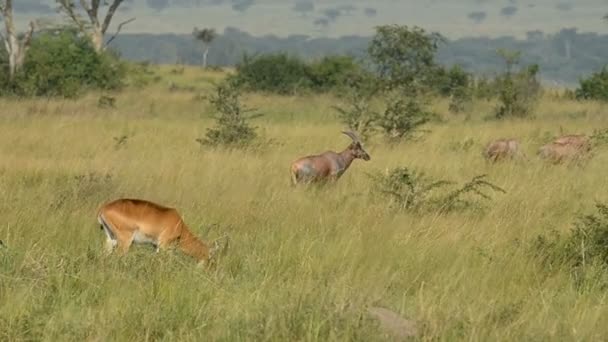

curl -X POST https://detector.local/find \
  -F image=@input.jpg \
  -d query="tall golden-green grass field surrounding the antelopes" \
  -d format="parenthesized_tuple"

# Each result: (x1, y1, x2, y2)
(0, 67, 608, 341)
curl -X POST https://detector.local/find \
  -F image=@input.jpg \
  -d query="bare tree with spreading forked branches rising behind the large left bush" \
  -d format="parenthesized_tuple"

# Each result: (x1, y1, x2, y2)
(56, 0, 135, 53)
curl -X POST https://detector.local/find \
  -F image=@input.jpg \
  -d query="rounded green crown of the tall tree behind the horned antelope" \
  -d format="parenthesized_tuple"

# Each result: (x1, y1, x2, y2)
(367, 25, 443, 89)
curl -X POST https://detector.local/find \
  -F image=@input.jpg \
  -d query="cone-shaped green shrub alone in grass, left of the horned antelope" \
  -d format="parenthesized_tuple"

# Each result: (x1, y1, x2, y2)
(197, 82, 260, 147)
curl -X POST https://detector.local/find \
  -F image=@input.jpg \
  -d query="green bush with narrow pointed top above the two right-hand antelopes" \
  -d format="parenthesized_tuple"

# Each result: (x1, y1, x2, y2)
(495, 50, 541, 119)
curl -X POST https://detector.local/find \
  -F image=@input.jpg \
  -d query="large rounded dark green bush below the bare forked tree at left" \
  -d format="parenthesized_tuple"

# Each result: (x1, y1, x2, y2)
(12, 30, 126, 97)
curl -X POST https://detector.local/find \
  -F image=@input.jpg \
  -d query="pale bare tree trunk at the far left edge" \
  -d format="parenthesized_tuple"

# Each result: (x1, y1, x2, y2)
(0, 0, 35, 81)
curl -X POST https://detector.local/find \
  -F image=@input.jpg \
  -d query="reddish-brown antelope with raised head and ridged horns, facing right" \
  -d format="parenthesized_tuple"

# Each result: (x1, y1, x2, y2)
(291, 131, 371, 185)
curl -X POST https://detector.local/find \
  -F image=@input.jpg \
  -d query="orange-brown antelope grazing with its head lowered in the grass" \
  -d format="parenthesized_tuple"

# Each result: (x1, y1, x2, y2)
(97, 198, 218, 265)
